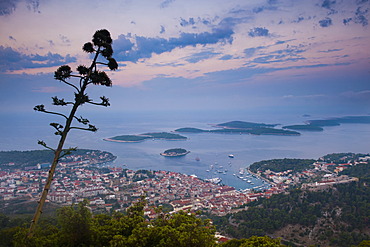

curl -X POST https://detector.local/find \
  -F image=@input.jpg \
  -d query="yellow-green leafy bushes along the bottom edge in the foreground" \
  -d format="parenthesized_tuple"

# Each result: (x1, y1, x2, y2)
(0, 198, 284, 247)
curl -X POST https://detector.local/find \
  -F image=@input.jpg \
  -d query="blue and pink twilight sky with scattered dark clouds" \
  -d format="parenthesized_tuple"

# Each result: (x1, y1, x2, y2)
(0, 0, 370, 118)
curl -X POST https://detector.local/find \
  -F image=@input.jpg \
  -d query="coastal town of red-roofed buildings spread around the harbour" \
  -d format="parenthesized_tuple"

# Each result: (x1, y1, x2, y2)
(0, 151, 370, 217)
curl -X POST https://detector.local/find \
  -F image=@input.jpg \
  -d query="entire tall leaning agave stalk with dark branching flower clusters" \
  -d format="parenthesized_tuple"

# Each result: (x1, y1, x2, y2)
(28, 29, 118, 237)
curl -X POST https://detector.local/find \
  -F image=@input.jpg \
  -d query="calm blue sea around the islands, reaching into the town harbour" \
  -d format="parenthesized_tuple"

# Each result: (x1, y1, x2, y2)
(0, 109, 370, 190)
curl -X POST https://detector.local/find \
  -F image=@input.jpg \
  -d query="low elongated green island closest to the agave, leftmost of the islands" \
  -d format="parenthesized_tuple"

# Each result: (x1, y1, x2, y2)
(104, 132, 187, 142)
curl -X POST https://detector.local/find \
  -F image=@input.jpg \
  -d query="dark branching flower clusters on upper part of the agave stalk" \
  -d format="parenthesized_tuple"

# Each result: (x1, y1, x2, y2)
(34, 29, 118, 143)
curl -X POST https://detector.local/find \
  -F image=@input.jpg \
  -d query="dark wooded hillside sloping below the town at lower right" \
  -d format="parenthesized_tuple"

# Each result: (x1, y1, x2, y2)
(213, 163, 370, 247)
